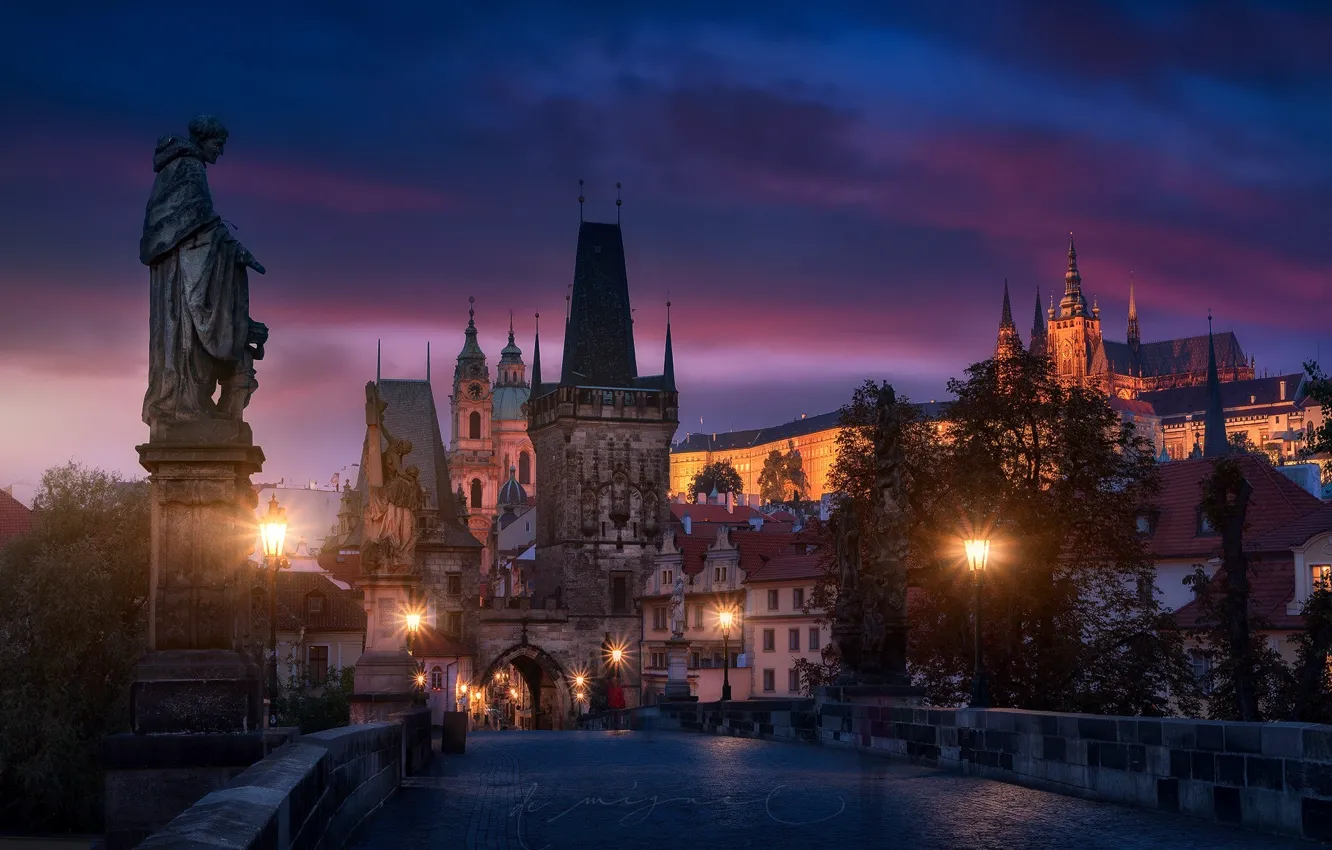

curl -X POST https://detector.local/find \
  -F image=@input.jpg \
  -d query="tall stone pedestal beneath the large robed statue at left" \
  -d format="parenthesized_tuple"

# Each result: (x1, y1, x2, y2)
(103, 442, 266, 849)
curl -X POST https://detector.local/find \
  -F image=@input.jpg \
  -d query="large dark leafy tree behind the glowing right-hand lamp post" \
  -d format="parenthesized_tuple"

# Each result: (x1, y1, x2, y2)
(811, 350, 1196, 715)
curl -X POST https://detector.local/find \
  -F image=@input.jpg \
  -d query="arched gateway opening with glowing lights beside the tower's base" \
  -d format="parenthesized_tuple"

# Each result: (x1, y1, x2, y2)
(478, 643, 574, 729)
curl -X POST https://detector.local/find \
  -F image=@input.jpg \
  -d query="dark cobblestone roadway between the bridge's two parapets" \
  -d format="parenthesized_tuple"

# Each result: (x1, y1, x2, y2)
(349, 731, 1311, 850)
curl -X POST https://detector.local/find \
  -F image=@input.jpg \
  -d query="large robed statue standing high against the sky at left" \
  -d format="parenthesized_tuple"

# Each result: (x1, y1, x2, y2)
(139, 116, 268, 444)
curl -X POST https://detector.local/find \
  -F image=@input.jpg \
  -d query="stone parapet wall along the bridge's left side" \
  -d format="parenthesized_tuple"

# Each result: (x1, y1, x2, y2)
(139, 709, 430, 850)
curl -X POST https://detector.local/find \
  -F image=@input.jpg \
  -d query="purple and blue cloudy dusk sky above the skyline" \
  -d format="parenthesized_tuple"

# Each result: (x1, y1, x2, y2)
(0, 0, 1332, 495)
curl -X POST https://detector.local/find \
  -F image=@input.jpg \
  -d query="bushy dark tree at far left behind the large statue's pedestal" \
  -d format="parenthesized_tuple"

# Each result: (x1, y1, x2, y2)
(0, 464, 149, 831)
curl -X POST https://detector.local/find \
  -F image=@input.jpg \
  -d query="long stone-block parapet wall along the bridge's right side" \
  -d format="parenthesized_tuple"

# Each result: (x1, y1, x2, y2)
(639, 699, 1332, 841)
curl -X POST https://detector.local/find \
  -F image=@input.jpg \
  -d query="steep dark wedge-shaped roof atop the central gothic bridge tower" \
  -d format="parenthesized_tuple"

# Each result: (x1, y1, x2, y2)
(559, 221, 638, 386)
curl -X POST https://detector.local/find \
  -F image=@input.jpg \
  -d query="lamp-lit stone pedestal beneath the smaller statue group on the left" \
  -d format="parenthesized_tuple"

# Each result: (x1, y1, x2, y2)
(352, 576, 417, 723)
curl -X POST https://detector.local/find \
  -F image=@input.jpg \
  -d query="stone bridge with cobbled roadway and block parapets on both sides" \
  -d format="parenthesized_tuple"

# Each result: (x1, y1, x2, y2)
(137, 701, 1332, 850)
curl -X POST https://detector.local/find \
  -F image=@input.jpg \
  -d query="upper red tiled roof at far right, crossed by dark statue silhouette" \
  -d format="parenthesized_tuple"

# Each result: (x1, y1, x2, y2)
(1148, 454, 1323, 558)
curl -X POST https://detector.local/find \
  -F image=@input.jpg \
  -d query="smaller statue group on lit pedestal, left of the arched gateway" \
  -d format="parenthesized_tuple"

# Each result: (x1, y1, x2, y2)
(361, 381, 425, 576)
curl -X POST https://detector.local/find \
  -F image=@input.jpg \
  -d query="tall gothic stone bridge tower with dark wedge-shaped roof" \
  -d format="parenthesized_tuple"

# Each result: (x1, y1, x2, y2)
(478, 213, 679, 727)
